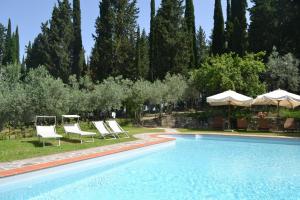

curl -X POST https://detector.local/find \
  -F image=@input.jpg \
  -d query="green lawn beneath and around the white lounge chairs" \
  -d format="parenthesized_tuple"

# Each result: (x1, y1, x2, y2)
(0, 123, 162, 162)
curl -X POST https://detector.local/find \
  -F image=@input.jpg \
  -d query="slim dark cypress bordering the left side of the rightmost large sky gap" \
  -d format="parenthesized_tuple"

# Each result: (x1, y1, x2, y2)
(184, 0, 198, 68)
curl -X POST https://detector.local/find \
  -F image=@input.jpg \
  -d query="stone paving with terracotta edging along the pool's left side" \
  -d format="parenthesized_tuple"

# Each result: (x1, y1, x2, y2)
(0, 130, 175, 178)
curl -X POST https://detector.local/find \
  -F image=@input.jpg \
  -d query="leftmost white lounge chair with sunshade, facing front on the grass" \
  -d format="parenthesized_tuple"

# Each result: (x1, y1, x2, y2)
(35, 116, 62, 147)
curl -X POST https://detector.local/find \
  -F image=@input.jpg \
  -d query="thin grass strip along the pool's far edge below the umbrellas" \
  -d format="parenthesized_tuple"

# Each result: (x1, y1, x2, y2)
(177, 128, 300, 137)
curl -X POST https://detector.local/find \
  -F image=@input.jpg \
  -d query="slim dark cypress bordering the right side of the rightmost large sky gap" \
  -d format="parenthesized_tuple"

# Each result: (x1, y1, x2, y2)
(211, 0, 225, 54)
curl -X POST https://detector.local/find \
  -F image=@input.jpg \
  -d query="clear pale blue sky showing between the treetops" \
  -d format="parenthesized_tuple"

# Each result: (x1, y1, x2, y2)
(0, 0, 251, 59)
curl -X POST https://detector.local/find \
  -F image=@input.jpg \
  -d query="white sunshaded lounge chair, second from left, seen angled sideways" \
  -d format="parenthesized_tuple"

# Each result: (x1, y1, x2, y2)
(62, 115, 96, 144)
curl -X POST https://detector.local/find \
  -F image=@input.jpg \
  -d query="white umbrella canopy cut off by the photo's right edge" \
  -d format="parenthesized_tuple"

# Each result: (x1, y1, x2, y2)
(253, 89, 300, 108)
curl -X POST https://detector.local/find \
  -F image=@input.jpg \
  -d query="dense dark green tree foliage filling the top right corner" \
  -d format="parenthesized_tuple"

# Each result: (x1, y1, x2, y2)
(249, 0, 300, 58)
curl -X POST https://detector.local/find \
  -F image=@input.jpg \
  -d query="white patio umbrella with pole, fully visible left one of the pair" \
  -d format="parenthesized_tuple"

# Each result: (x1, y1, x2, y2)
(206, 90, 253, 129)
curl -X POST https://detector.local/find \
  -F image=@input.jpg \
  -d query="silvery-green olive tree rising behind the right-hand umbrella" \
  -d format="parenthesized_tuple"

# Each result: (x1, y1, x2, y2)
(267, 48, 300, 92)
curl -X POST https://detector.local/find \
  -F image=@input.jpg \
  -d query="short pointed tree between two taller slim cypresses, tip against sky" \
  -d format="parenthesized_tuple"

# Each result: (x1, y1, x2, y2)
(197, 26, 209, 64)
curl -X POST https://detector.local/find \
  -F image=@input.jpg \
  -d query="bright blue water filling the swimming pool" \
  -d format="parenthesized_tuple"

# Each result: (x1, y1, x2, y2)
(0, 136, 300, 200)
